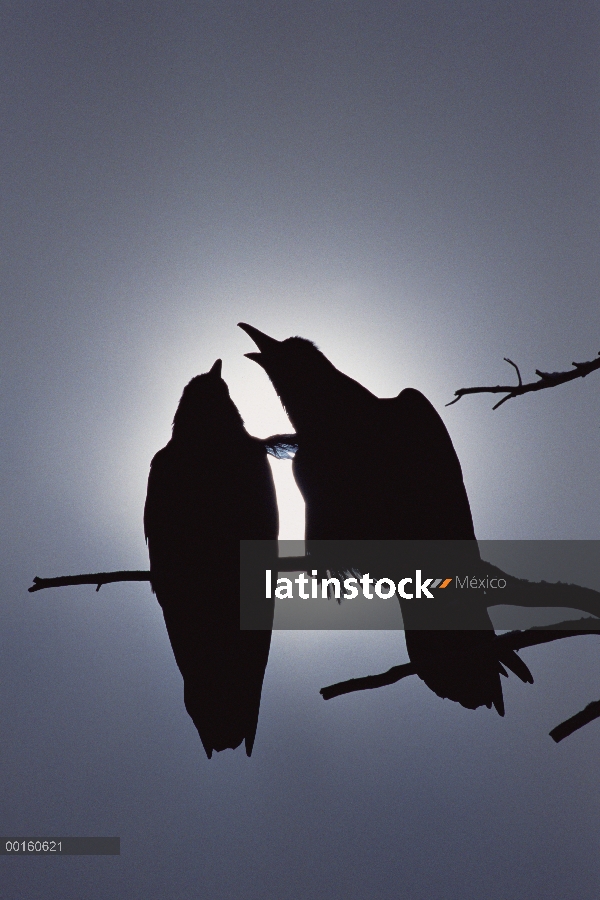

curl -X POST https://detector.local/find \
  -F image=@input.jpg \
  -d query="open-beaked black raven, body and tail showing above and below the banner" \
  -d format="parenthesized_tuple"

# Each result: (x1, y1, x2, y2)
(239, 323, 524, 715)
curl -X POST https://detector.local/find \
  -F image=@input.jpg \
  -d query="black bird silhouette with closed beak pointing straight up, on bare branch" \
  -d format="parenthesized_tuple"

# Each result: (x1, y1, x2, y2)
(144, 359, 279, 759)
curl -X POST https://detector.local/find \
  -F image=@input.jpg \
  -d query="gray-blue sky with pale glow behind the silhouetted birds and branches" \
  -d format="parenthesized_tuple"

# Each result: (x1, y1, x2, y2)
(0, 0, 600, 900)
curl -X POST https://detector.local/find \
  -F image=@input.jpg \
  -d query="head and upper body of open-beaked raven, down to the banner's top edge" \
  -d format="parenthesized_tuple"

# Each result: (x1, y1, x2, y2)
(240, 323, 475, 540)
